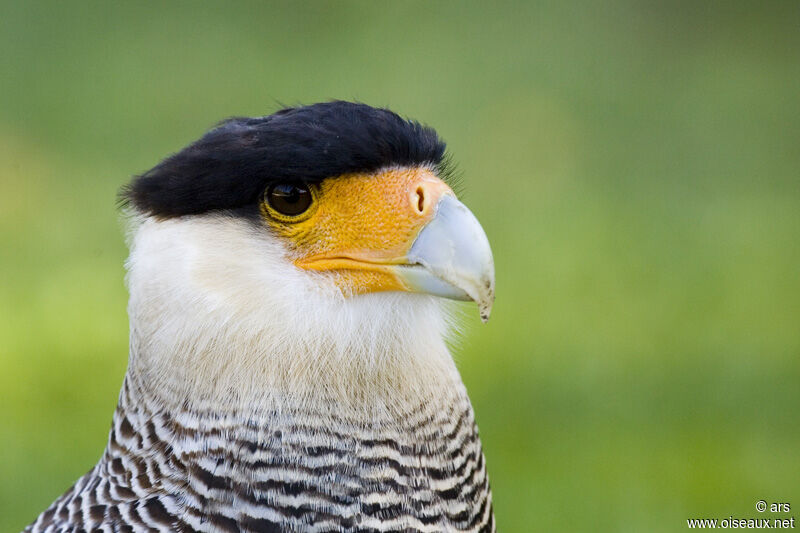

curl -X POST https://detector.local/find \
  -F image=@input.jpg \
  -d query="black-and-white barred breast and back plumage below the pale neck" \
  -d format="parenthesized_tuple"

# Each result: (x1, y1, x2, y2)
(25, 375, 494, 533)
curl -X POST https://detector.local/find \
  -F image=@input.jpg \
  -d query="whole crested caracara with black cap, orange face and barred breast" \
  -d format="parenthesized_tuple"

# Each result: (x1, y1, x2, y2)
(25, 101, 496, 533)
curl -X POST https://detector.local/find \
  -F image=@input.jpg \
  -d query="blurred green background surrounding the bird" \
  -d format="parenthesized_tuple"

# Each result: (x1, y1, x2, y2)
(0, 1, 800, 532)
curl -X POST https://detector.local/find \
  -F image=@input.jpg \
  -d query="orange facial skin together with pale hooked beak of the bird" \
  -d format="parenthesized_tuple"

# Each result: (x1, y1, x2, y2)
(287, 168, 494, 322)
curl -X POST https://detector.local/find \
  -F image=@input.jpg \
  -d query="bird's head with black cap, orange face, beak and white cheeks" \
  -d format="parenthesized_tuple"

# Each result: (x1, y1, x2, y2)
(123, 102, 494, 404)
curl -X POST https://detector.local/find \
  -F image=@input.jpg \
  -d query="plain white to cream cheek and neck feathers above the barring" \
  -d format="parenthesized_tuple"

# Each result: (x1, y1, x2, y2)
(127, 215, 462, 412)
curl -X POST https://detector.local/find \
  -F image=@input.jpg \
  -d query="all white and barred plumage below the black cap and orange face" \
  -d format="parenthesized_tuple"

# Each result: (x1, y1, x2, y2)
(26, 214, 494, 532)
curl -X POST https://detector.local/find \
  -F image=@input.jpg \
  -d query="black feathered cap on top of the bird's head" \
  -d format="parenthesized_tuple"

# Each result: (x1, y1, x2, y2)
(121, 102, 446, 217)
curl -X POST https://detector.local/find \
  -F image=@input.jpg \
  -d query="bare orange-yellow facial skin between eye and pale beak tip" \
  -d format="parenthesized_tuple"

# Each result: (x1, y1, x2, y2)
(262, 167, 453, 294)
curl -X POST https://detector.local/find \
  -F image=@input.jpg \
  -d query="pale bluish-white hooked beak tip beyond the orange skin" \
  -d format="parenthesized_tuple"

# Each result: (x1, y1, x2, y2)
(390, 194, 494, 322)
